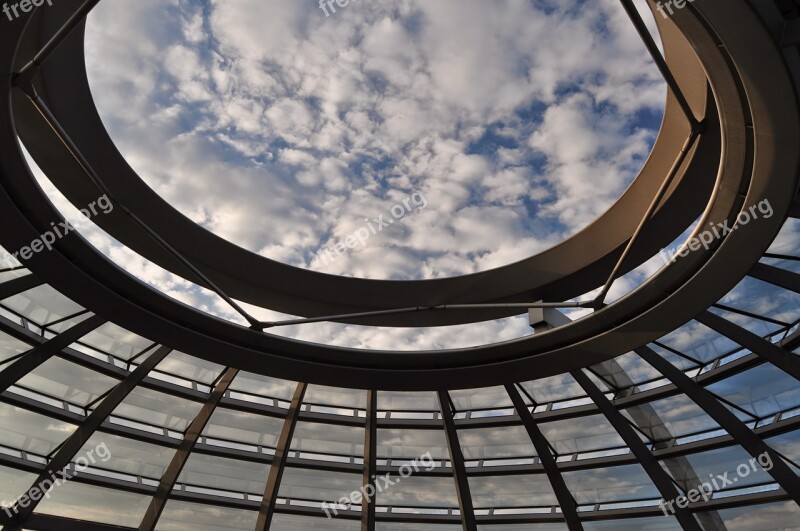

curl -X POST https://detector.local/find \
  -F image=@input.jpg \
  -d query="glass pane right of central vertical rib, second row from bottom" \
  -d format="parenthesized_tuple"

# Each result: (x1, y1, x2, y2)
(377, 475, 458, 508)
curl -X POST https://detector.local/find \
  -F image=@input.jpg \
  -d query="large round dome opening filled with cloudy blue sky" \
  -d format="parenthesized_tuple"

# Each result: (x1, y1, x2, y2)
(87, 0, 666, 280)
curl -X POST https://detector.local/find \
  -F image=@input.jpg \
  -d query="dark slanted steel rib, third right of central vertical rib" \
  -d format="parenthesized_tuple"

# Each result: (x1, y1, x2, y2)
(570, 371, 702, 531)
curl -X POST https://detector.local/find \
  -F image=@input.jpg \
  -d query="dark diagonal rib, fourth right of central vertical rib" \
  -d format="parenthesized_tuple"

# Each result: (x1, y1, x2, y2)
(635, 347, 800, 504)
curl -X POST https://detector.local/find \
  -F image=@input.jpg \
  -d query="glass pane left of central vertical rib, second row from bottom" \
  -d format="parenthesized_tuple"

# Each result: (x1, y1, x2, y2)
(278, 466, 361, 503)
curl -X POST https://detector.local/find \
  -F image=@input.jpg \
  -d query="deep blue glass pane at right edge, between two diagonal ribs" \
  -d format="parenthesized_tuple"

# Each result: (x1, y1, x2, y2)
(708, 363, 800, 417)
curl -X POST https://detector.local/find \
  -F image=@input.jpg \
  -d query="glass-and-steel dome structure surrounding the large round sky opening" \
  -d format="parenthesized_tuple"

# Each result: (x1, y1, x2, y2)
(0, 0, 800, 531)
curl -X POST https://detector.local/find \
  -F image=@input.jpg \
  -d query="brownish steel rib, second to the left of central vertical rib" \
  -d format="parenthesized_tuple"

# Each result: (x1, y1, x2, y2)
(139, 368, 239, 531)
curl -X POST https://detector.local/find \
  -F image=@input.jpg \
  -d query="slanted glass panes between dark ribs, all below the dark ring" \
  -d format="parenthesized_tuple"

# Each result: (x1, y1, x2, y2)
(0, 214, 800, 530)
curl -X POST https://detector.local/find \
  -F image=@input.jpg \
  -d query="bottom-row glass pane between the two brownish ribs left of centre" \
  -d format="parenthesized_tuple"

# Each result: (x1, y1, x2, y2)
(156, 500, 258, 531)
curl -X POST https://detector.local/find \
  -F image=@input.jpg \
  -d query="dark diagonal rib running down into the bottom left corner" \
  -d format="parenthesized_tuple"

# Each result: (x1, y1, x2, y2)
(3, 347, 172, 531)
